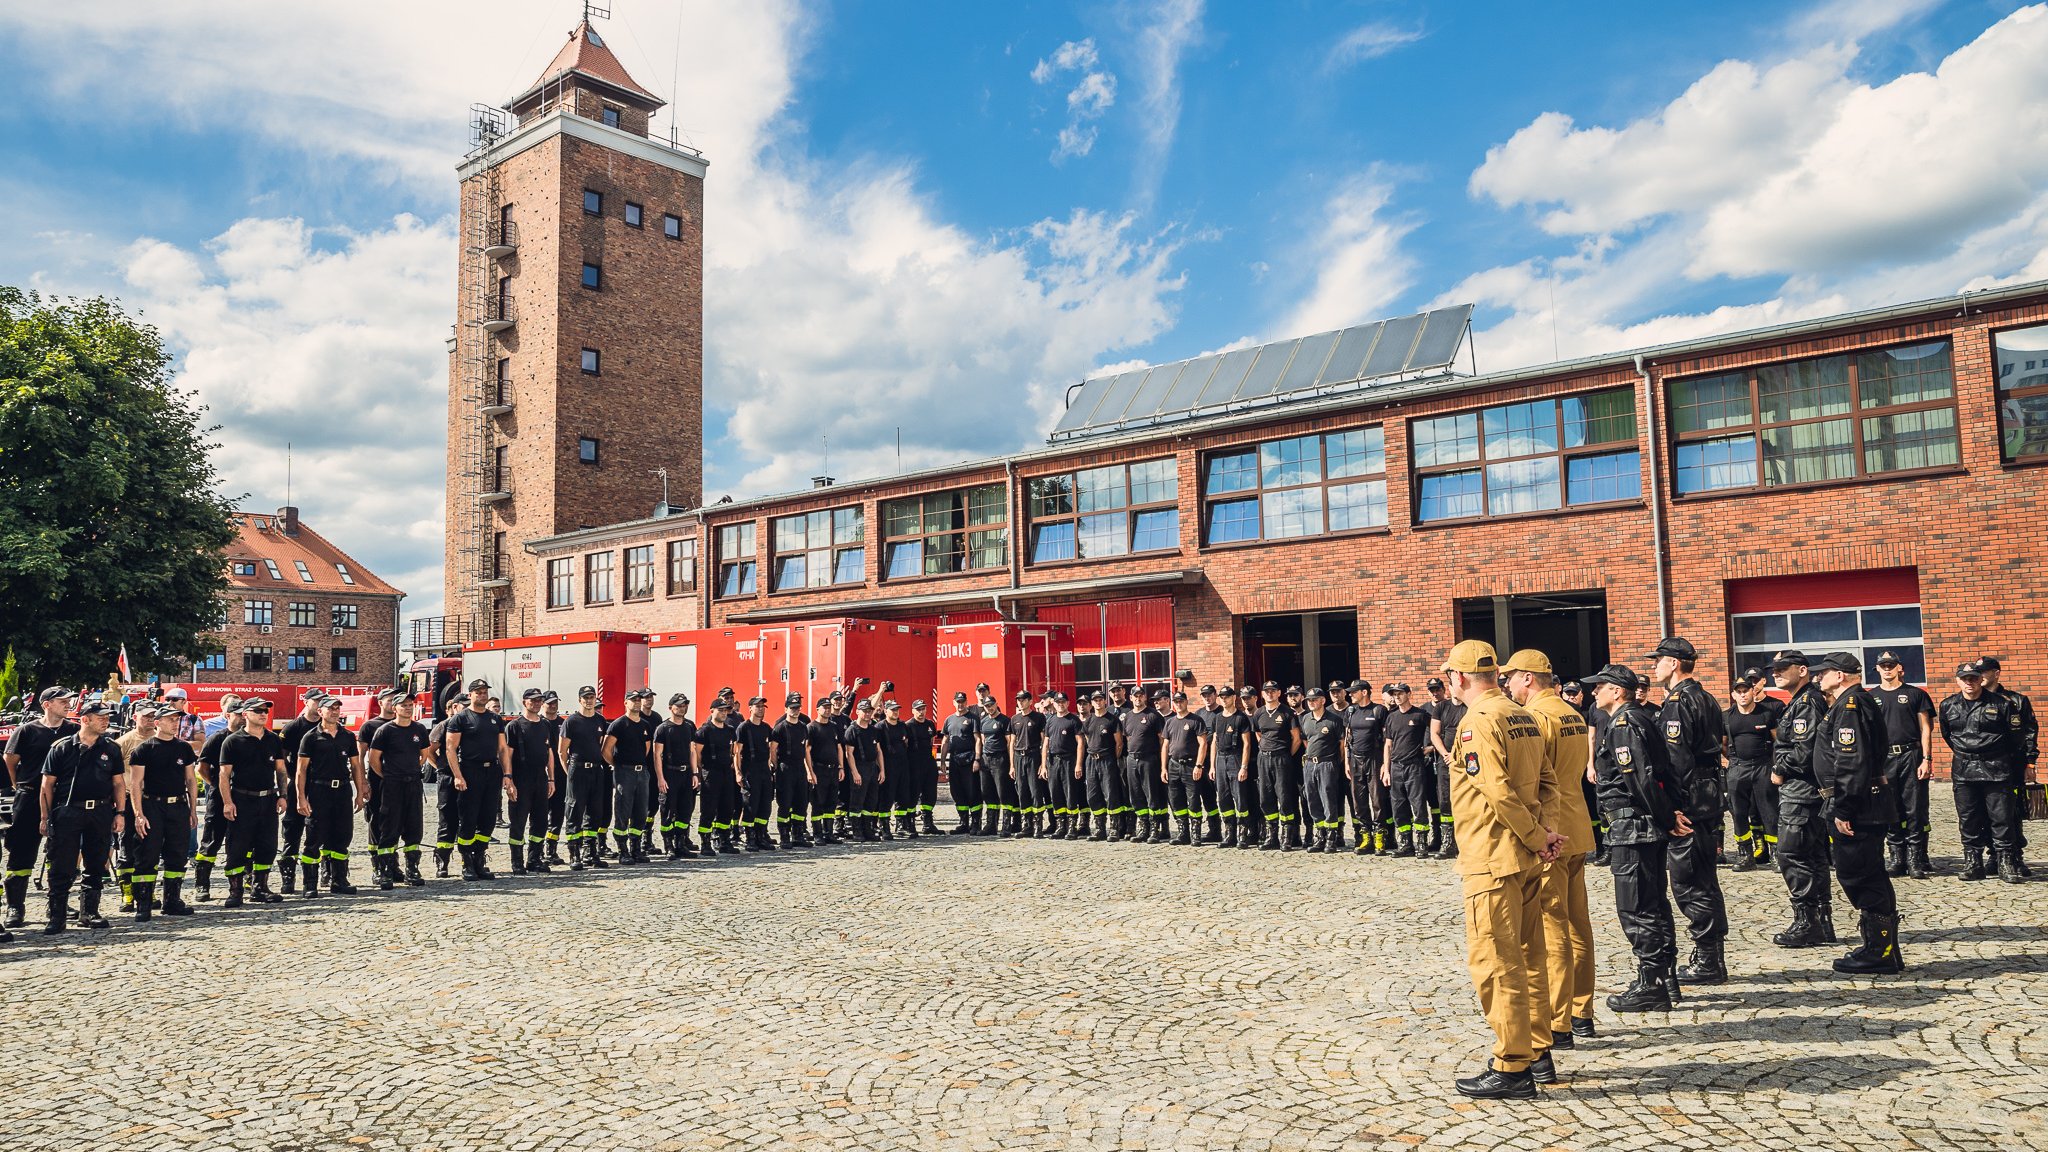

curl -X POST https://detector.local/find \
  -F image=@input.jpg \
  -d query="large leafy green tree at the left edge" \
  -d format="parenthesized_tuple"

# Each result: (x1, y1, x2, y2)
(0, 287, 236, 685)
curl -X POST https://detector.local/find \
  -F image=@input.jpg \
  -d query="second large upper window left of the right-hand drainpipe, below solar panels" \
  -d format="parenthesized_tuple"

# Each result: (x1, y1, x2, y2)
(1196, 428, 1386, 541)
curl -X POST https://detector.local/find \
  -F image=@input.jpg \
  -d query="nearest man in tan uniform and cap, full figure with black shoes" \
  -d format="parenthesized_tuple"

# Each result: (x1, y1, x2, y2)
(1442, 640, 1565, 1101)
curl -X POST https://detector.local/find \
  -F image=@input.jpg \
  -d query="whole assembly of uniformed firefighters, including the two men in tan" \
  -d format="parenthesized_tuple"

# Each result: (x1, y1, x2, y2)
(0, 637, 2038, 1097)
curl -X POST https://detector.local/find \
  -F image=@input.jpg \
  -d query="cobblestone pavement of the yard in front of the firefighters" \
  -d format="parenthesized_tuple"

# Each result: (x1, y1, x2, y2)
(0, 787, 2048, 1152)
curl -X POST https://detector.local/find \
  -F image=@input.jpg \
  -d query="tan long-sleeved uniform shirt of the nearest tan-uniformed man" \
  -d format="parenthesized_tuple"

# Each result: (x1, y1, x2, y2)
(1446, 689, 1546, 875)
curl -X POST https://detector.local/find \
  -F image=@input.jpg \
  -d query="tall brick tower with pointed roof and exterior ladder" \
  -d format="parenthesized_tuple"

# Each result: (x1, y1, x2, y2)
(444, 20, 705, 642)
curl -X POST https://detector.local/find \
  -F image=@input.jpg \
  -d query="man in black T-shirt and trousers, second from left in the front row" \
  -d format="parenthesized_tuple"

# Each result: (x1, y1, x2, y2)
(37, 701, 127, 935)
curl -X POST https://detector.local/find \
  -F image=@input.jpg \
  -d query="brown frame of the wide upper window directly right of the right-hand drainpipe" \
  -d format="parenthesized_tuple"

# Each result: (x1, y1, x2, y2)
(1661, 336, 1962, 500)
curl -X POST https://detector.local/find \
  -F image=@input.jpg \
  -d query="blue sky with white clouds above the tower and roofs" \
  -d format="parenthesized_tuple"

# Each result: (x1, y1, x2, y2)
(0, 0, 2048, 611)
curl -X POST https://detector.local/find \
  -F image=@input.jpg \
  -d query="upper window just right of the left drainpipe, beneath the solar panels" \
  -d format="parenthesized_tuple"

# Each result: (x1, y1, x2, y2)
(1026, 457, 1180, 564)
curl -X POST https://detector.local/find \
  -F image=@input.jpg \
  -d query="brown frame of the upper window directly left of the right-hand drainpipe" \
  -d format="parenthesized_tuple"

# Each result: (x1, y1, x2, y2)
(1407, 383, 1642, 527)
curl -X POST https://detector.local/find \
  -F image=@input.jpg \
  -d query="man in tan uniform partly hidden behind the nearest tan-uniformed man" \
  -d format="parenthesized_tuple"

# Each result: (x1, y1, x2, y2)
(1501, 648, 1593, 1047)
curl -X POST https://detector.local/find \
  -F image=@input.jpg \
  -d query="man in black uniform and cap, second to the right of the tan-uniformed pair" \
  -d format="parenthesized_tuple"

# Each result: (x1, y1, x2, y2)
(1645, 635, 1729, 984)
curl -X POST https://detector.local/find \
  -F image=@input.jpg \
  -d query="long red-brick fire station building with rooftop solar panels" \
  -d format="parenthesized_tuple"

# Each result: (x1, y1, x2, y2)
(524, 283, 2048, 697)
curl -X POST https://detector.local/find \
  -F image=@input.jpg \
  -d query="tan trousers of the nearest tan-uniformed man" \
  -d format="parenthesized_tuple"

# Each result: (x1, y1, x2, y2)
(1464, 867, 1550, 1072)
